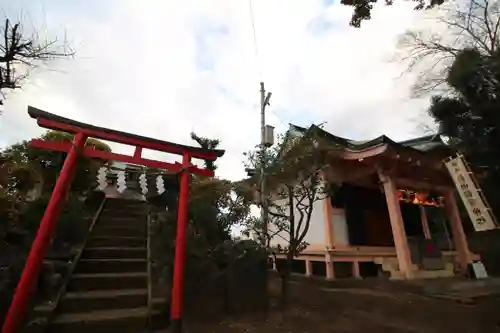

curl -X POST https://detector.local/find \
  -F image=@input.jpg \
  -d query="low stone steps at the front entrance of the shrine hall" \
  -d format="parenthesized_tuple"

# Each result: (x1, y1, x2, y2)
(375, 257, 455, 280)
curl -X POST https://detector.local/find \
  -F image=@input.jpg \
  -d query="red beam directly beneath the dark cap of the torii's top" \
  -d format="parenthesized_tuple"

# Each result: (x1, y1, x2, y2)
(38, 118, 221, 160)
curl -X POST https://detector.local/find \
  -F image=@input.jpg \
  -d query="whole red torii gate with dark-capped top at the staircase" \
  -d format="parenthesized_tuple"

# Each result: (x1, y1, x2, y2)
(2, 106, 224, 333)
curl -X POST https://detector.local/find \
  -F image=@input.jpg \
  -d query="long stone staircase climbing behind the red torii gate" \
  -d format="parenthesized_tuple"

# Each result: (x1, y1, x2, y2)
(47, 199, 162, 333)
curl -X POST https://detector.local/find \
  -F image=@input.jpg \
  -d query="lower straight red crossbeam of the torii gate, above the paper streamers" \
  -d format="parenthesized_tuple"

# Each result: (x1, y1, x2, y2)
(31, 139, 214, 177)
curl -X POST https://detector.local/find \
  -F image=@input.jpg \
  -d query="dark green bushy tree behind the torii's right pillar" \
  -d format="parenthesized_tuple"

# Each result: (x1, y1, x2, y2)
(150, 133, 266, 311)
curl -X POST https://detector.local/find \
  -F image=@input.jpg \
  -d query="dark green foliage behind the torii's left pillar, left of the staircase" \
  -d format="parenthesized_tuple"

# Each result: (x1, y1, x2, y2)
(0, 131, 110, 321)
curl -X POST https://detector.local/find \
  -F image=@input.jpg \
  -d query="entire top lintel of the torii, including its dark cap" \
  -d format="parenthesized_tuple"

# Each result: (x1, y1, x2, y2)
(28, 106, 225, 160)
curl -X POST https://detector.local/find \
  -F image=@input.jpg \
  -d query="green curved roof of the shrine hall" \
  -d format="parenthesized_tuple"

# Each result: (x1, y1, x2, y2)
(290, 124, 446, 153)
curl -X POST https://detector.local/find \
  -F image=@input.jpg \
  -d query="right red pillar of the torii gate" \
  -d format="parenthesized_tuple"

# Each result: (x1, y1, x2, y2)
(170, 153, 191, 333)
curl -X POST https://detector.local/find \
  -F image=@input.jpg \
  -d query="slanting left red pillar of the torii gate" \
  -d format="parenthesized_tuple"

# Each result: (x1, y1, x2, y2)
(2, 133, 87, 333)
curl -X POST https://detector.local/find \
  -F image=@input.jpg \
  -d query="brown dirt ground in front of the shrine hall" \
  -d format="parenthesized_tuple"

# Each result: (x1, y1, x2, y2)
(186, 279, 500, 333)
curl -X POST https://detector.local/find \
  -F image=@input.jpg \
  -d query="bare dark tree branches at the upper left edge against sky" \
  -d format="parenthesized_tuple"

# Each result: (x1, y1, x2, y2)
(0, 18, 74, 105)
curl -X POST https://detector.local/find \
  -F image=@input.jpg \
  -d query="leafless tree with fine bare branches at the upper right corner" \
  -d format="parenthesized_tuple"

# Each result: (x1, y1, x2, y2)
(398, 0, 500, 97)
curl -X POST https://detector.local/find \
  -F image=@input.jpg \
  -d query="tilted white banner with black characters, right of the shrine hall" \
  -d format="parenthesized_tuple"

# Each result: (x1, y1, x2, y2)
(445, 155, 496, 231)
